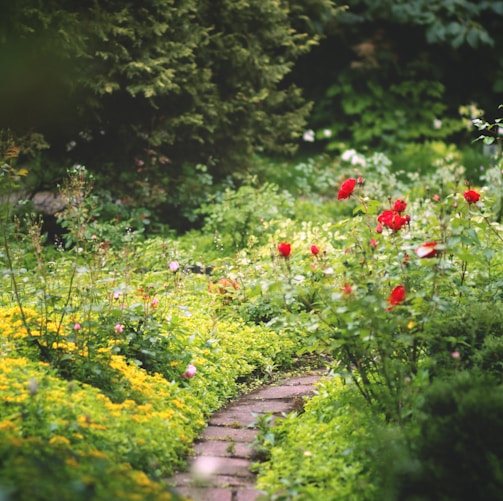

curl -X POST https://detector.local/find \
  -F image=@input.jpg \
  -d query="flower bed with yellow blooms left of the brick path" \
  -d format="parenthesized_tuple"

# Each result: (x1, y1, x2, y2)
(0, 158, 304, 500)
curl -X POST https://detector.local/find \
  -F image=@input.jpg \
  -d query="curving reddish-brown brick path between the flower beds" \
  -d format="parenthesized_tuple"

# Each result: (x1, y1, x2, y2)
(168, 371, 323, 501)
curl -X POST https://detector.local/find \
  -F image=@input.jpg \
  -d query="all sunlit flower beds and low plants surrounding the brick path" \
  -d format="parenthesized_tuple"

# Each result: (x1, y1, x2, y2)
(0, 135, 503, 500)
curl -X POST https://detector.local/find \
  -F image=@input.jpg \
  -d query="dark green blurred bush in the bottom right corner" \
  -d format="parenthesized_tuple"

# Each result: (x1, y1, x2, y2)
(376, 373, 503, 501)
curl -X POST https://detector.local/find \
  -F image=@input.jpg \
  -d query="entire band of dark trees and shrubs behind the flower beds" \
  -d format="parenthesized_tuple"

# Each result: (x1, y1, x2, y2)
(0, 0, 503, 230)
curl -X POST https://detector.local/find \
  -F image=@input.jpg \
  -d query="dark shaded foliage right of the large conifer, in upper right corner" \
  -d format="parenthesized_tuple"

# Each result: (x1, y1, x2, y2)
(294, 0, 503, 151)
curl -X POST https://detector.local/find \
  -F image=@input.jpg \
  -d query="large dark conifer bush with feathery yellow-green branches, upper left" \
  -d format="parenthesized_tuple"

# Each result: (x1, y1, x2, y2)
(0, 0, 333, 224)
